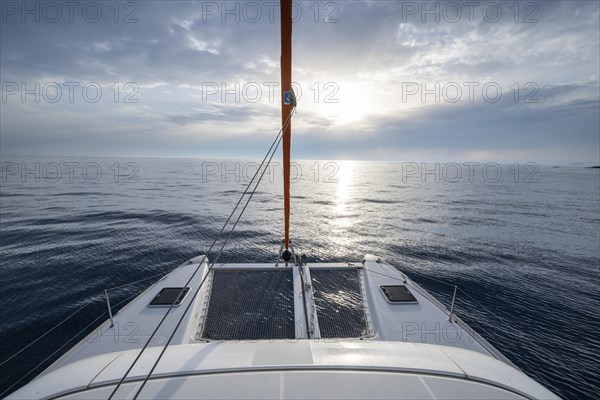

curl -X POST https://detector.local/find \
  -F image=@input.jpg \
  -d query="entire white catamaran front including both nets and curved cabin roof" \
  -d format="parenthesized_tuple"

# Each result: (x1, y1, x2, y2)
(11, 255, 556, 399)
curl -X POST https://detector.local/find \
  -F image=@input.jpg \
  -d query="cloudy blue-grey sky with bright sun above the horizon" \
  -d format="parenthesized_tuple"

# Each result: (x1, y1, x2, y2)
(0, 0, 600, 164)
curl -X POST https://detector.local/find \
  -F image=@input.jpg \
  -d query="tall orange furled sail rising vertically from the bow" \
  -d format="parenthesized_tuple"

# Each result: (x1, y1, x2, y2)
(280, 0, 295, 250)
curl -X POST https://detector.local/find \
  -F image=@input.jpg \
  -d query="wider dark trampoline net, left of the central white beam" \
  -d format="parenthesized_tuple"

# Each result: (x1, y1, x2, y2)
(202, 269, 295, 340)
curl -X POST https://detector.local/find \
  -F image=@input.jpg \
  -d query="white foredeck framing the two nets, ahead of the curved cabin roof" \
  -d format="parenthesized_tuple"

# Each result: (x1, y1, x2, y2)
(38, 255, 507, 369)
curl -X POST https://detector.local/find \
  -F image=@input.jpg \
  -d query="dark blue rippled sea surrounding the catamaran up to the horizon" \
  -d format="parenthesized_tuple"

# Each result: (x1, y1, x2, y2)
(0, 157, 600, 399)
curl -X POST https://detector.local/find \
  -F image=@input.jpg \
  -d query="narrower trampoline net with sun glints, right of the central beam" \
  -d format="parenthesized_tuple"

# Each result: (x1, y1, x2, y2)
(310, 268, 368, 338)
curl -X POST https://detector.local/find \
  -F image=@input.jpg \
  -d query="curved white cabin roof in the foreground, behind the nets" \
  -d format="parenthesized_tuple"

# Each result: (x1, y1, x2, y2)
(11, 339, 556, 399)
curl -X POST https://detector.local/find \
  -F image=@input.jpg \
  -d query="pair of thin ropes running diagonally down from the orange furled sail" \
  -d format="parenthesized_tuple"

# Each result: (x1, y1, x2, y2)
(108, 107, 295, 400)
